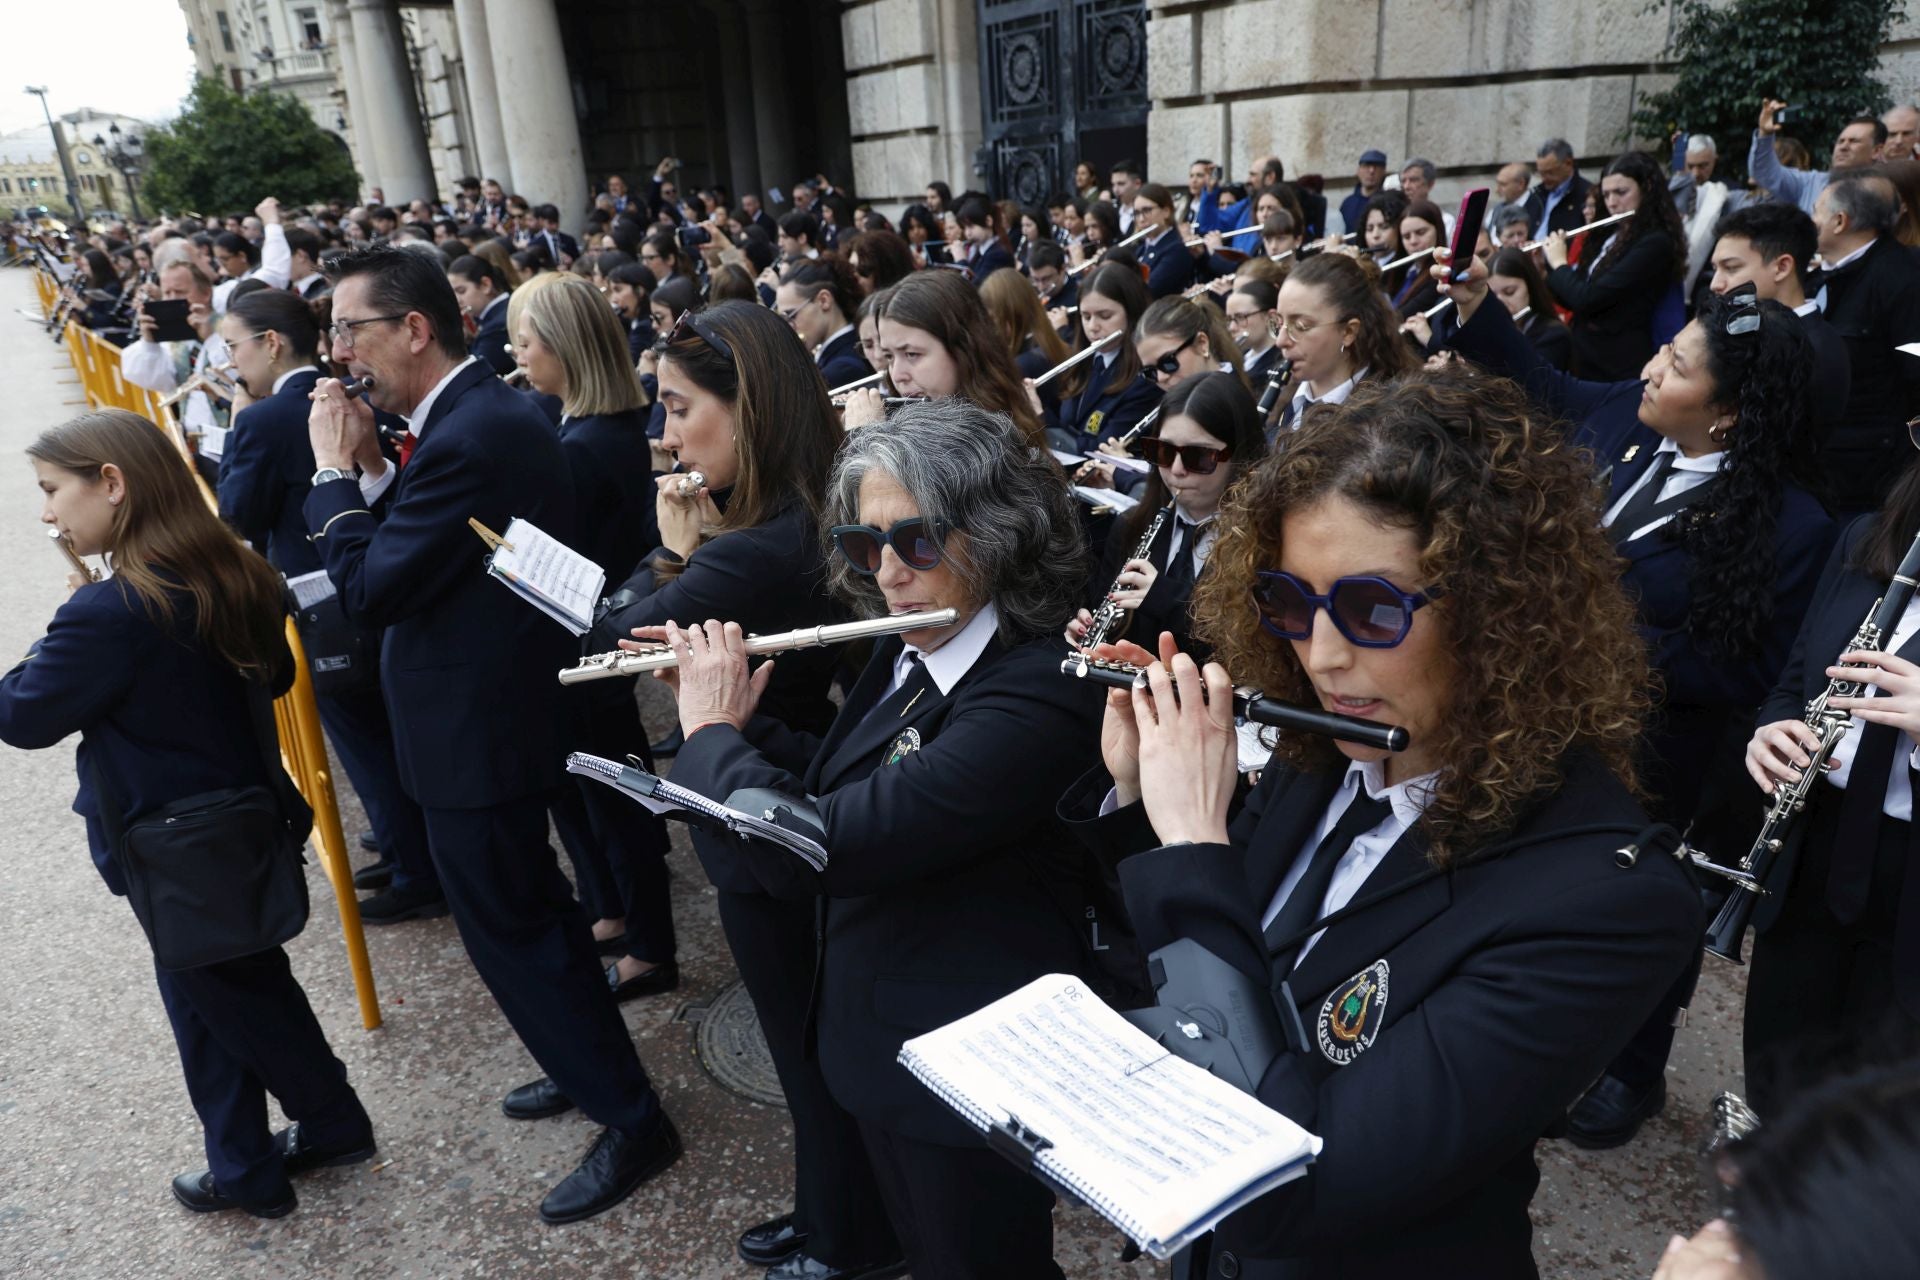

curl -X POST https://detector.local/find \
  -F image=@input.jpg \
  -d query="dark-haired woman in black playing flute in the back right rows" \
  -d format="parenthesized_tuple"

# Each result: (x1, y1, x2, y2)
(1544, 152, 1686, 382)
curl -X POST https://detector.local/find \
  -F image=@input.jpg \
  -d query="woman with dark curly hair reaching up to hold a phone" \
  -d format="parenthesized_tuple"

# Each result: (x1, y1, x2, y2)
(1442, 251, 1834, 1148)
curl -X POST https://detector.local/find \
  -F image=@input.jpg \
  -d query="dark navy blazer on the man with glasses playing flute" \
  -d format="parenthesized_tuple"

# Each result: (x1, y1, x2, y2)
(305, 363, 580, 808)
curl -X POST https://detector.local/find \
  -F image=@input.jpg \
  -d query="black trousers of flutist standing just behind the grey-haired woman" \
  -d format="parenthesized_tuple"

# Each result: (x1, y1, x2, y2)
(720, 889, 900, 1267)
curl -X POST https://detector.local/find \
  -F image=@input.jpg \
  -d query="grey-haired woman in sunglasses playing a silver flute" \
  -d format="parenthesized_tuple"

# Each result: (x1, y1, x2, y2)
(662, 399, 1100, 1280)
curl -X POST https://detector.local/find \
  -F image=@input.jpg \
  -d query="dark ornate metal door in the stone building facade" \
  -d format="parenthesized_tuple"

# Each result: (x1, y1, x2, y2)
(977, 0, 1146, 205)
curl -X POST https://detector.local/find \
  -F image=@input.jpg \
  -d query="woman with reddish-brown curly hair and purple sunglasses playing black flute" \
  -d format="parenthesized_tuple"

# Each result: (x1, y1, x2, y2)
(1062, 372, 1705, 1280)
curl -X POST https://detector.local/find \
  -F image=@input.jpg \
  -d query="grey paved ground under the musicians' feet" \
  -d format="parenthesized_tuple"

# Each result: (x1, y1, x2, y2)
(0, 262, 1740, 1280)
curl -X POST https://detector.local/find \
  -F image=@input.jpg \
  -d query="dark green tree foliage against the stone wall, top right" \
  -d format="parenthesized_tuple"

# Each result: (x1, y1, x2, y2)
(1634, 0, 1905, 180)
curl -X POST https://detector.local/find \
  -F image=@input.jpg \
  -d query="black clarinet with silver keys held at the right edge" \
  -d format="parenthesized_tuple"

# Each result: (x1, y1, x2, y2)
(1693, 535, 1920, 965)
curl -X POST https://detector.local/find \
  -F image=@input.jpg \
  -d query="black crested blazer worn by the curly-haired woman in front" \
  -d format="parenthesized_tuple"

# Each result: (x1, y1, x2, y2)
(1062, 758, 1705, 1280)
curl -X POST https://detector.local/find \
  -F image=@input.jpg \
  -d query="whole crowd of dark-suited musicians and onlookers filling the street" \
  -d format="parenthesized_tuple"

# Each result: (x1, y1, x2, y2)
(11, 100, 1920, 1280)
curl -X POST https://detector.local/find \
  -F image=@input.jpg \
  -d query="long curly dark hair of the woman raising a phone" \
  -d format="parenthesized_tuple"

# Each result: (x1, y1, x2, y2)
(1667, 284, 1820, 662)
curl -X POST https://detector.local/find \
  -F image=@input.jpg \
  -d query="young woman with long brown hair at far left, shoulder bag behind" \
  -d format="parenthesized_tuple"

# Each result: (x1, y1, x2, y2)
(0, 409, 372, 1217)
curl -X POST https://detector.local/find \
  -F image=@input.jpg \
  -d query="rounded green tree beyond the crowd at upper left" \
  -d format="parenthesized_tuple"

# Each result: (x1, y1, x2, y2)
(144, 79, 359, 213)
